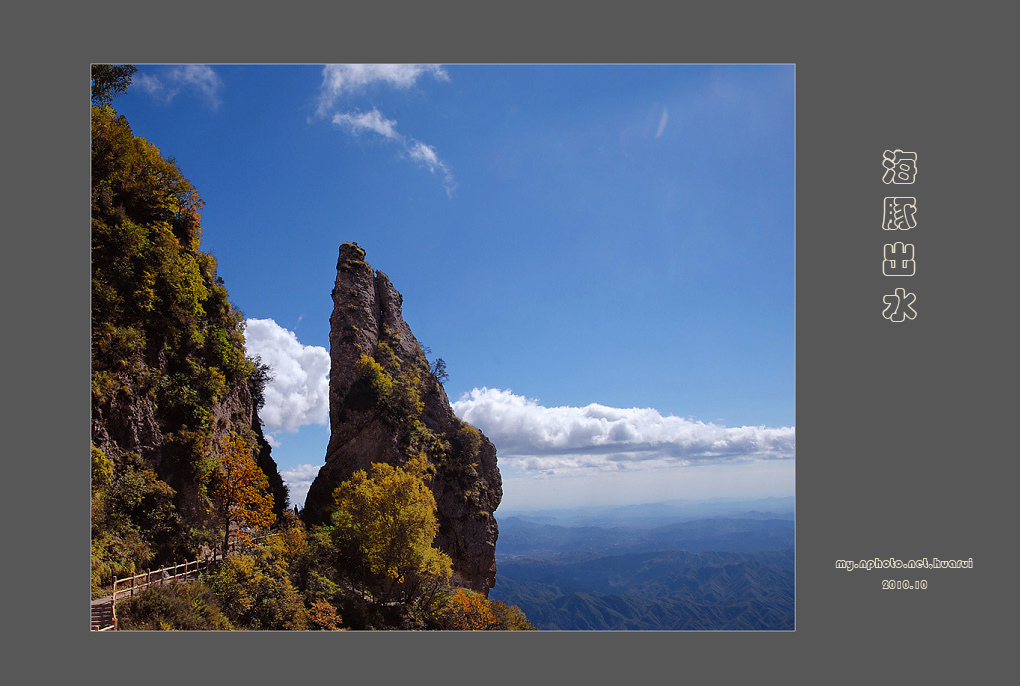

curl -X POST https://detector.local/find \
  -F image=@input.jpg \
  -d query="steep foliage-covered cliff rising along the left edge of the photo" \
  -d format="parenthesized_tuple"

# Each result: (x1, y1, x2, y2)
(90, 106, 287, 586)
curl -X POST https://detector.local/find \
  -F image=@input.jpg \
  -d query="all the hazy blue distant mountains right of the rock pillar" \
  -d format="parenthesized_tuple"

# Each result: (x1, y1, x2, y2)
(490, 498, 796, 631)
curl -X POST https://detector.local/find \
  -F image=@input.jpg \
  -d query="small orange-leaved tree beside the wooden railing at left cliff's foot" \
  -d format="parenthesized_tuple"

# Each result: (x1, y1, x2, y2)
(210, 436, 276, 557)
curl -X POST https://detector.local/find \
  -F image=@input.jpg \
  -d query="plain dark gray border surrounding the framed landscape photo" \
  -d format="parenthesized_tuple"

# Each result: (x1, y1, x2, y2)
(11, 2, 1017, 683)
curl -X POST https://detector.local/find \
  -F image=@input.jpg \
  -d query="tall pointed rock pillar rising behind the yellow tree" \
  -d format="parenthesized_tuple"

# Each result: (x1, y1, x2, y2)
(303, 244, 503, 594)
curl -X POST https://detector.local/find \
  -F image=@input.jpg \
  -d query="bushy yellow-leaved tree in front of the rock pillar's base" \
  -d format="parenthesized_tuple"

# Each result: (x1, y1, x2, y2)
(333, 455, 453, 603)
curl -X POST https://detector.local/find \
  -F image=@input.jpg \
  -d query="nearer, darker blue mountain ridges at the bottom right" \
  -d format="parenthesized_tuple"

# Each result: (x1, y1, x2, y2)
(489, 549, 795, 631)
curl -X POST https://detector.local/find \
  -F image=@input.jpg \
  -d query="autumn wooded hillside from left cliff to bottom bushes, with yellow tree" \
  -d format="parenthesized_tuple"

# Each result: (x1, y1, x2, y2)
(91, 65, 533, 630)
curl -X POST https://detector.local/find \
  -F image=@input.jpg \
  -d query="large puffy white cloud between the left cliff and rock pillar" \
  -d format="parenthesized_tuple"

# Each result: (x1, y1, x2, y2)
(245, 319, 329, 431)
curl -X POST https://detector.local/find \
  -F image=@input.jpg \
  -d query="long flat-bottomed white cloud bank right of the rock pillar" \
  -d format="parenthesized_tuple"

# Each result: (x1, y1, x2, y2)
(453, 388, 796, 474)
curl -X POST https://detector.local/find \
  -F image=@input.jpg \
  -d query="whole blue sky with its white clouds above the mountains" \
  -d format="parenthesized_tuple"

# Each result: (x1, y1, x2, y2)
(113, 64, 796, 511)
